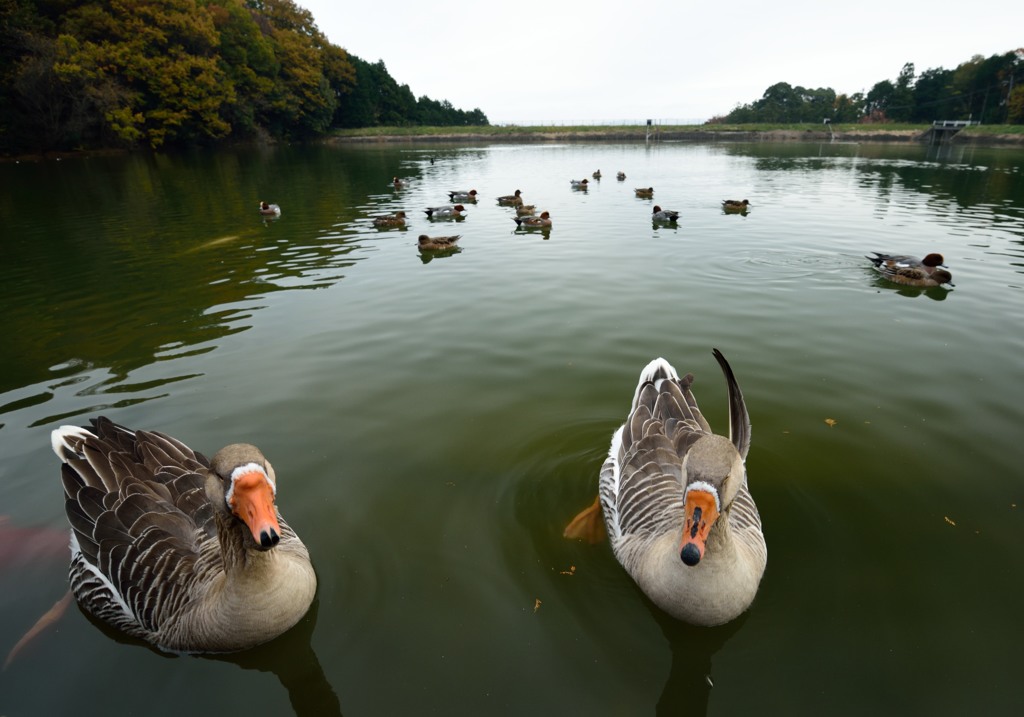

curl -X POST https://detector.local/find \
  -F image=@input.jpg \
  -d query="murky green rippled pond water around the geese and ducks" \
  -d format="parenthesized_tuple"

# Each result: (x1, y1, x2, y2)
(0, 142, 1024, 717)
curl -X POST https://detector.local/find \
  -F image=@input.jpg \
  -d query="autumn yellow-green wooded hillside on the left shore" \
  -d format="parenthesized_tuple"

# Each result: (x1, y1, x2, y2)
(0, 0, 488, 153)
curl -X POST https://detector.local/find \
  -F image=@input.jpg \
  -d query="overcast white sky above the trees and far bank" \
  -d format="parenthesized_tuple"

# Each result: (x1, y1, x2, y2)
(296, 0, 1024, 124)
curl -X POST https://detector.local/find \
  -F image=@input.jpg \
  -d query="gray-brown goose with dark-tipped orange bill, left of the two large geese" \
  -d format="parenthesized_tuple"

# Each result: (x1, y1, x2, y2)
(52, 417, 316, 652)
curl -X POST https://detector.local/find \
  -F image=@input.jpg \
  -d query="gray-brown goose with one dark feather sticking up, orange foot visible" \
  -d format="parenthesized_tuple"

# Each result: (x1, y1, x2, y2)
(566, 349, 768, 626)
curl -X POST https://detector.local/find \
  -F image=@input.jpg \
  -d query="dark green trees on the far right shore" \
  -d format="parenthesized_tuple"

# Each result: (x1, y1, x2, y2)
(709, 48, 1024, 124)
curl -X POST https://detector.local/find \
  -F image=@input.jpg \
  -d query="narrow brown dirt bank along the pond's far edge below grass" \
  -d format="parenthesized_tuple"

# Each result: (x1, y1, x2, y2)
(326, 128, 1024, 146)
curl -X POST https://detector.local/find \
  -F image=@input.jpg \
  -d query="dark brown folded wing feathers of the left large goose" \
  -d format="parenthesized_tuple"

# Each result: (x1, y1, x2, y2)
(55, 418, 210, 635)
